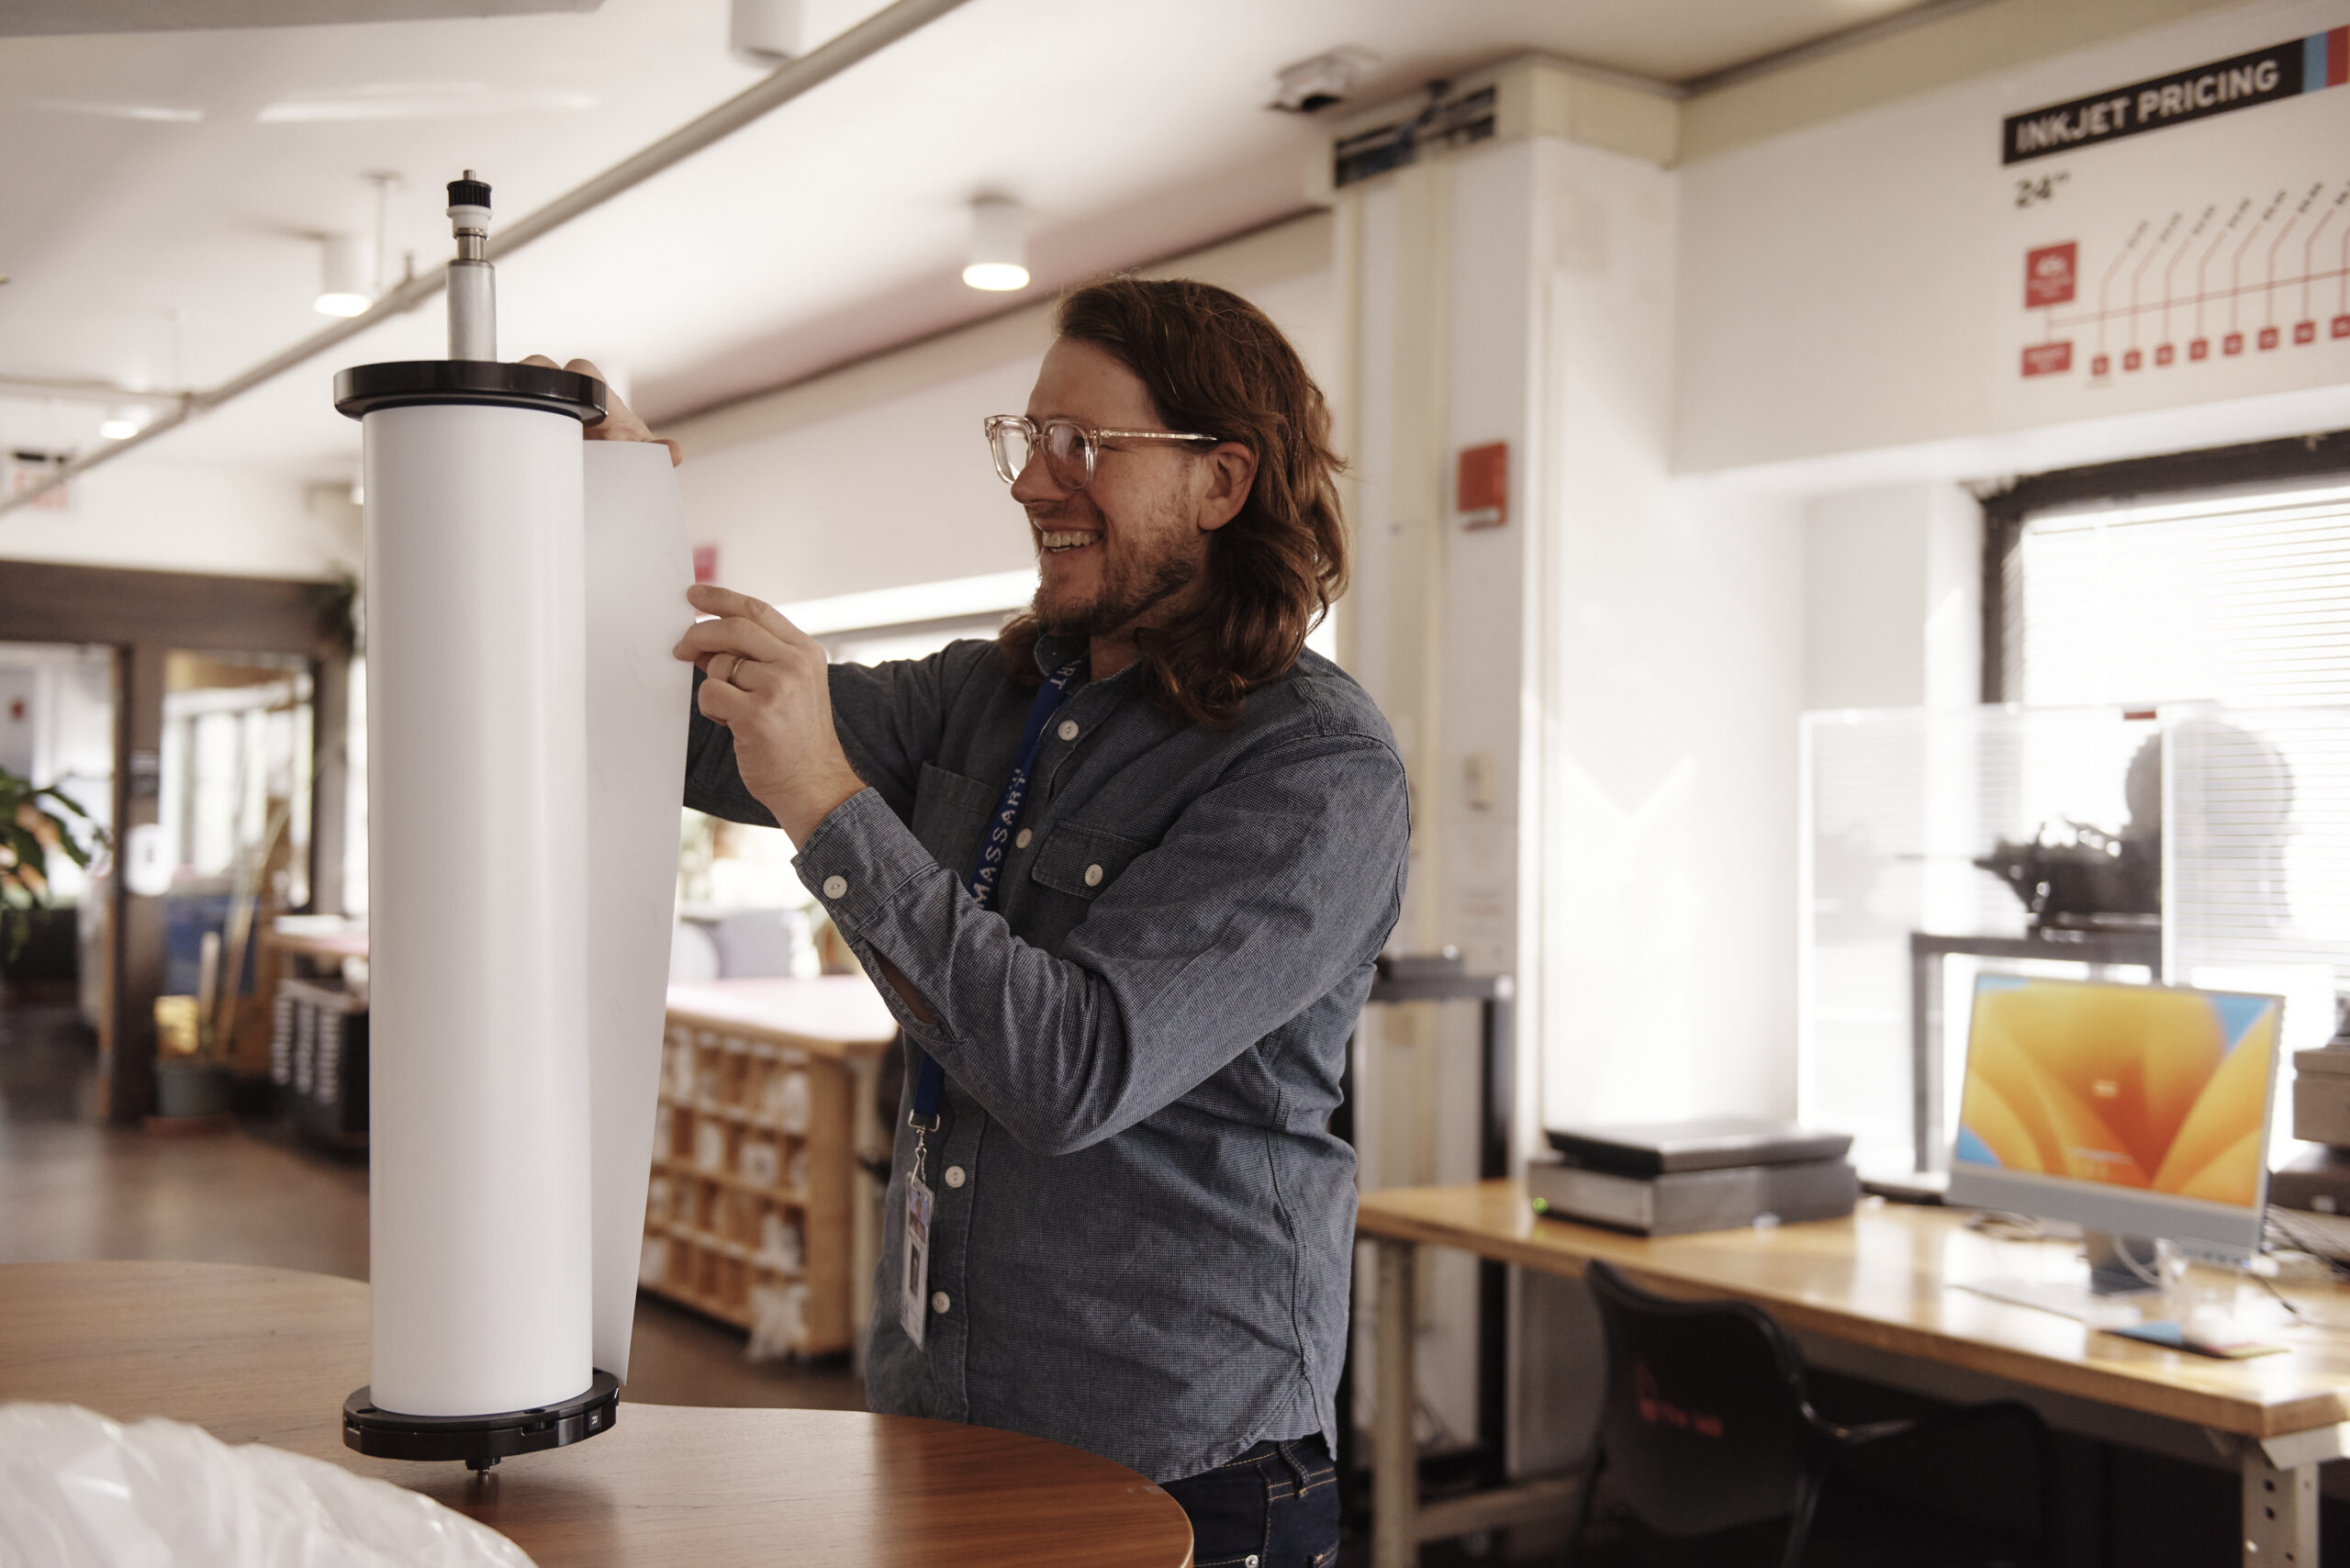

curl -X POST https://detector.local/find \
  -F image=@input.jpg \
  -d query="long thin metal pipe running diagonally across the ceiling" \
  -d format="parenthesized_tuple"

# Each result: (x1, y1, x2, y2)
(0, 0, 966, 517)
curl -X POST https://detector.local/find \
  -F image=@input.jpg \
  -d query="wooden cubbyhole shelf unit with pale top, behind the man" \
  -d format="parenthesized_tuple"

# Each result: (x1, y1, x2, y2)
(643, 976, 898, 1366)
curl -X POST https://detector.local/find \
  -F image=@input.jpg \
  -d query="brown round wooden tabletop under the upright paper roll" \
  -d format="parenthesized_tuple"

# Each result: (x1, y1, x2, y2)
(0, 1262, 1192, 1568)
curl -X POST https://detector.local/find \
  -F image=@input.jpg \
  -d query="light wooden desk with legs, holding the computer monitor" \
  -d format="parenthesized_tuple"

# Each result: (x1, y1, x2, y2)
(1356, 1180, 2350, 1568)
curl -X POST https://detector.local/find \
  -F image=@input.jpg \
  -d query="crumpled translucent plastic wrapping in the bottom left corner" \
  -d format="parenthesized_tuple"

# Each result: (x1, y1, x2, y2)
(0, 1404, 532, 1568)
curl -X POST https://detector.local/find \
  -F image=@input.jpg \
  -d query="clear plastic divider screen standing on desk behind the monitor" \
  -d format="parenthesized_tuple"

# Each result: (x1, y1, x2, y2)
(1797, 703, 2350, 1170)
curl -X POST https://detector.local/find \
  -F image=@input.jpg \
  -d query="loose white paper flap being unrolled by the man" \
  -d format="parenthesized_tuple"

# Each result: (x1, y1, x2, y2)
(585, 442, 693, 1383)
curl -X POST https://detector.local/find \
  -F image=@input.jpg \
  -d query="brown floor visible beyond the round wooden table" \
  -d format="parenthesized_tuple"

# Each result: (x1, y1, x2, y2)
(0, 994, 865, 1410)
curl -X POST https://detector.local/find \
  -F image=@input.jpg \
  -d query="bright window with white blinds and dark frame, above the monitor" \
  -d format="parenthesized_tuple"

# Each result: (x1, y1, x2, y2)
(2000, 475, 2350, 1104)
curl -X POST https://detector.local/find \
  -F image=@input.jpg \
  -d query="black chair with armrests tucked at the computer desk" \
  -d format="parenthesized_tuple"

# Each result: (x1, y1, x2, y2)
(1568, 1262, 2053, 1568)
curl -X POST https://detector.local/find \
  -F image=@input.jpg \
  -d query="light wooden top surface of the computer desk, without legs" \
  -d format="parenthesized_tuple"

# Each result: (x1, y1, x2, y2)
(1356, 1180, 2350, 1437)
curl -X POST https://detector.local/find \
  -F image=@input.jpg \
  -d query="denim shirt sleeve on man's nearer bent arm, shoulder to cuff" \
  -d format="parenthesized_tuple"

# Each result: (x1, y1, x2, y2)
(794, 734, 1410, 1154)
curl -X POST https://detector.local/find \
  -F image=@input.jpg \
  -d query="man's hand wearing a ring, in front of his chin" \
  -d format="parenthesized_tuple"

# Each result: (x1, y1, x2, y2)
(672, 583, 865, 844)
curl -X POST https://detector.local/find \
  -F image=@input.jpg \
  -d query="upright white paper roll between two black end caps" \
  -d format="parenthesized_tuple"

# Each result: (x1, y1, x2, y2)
(364, 404, 597, 1416)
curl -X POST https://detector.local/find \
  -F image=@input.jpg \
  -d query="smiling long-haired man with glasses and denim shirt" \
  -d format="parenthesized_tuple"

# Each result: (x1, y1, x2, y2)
(634, 277, 1410, 1568)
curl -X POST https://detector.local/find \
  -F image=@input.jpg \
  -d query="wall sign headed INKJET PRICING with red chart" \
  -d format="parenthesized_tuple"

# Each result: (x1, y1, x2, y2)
(1986, 3, 2350, 425)
